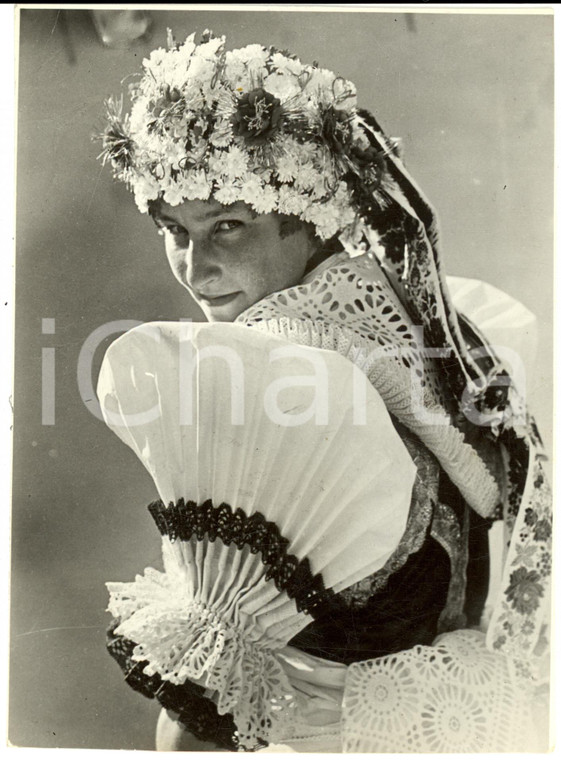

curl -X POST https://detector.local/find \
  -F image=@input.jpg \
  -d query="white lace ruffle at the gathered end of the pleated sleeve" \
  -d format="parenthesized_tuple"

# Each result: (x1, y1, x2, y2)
(107, 568, 297, 748)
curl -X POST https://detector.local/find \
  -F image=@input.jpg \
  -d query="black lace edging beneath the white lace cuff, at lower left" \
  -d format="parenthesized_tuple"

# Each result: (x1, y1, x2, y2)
(107, 620, 243, 752)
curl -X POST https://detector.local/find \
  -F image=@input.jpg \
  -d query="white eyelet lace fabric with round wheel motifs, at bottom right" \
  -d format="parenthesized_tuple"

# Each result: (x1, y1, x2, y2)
(342, 630, 543, 753)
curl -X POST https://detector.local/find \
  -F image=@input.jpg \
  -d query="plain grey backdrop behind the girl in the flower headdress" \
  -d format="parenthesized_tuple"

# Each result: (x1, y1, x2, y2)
(9, 9, 553, 749)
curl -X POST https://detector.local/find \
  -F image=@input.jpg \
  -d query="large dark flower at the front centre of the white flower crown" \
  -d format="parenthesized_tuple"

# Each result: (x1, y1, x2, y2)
(232, 87, 283, 145)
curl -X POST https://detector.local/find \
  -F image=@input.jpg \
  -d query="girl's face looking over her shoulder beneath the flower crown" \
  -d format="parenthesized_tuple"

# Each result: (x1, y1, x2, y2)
(151, 200, 315, 322)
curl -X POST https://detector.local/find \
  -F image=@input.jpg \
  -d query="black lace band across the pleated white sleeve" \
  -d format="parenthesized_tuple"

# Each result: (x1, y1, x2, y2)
(148, 499, 336, 618)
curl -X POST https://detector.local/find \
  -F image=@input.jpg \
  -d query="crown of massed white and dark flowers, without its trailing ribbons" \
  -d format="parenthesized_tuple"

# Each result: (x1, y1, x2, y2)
(100, 30, 394, 246)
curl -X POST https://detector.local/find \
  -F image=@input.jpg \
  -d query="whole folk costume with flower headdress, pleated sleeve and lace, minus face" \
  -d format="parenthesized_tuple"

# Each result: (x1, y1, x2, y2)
(99, 36, 551, 752)
